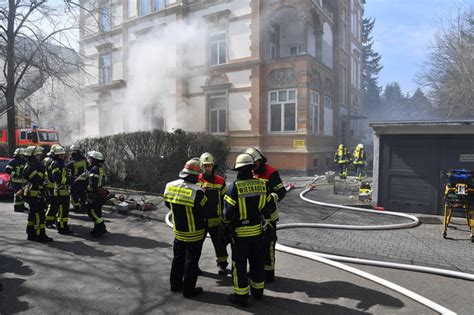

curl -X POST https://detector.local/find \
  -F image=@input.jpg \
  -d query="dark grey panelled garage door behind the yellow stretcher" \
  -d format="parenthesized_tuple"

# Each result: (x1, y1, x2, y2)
(378, 135, 474, 214)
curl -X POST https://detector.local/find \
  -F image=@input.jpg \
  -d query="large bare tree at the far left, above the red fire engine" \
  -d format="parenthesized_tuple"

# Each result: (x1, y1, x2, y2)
(0, 0, 92, 154)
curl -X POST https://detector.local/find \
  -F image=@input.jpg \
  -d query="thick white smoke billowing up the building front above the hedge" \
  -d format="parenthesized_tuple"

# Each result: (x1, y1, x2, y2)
(113, 18, 207, 133)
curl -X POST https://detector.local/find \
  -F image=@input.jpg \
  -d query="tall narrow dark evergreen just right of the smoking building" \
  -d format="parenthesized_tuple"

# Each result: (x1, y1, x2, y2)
(362, 18, 383, 118)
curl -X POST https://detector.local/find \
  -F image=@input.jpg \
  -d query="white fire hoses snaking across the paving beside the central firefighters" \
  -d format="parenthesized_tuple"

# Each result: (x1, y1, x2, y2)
(166, 176, 474, 314)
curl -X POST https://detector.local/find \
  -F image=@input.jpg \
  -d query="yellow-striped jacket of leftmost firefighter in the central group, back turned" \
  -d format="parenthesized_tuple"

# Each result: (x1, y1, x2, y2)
(164, 179, 207, 242)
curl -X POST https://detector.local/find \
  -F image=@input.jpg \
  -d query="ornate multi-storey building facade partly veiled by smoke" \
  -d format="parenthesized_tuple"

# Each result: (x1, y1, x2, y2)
(80, 0, 363, 172)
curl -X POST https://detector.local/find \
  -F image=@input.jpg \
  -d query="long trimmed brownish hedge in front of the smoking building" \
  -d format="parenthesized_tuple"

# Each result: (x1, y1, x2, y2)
(78, 130, 230, 193)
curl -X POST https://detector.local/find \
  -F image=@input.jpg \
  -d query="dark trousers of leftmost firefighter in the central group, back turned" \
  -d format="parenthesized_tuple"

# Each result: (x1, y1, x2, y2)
(170, 238, 204, 296)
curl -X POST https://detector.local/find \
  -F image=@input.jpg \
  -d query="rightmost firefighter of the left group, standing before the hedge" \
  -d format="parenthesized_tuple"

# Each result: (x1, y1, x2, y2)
(86, 151, 107, 237)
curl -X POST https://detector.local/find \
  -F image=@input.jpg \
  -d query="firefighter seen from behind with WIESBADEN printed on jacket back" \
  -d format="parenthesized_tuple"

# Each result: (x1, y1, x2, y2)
(222, 153, 272, 307)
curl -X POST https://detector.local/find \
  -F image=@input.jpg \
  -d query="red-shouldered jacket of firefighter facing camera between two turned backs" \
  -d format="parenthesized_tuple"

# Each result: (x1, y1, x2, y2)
(198, 174, 227, 227)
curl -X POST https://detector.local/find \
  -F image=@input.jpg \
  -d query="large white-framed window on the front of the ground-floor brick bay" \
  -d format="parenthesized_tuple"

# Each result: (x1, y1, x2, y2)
(269, 90, 296, 132)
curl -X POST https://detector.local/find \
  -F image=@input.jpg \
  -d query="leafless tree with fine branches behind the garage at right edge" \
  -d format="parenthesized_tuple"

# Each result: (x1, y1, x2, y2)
(418, 9, 474, 118)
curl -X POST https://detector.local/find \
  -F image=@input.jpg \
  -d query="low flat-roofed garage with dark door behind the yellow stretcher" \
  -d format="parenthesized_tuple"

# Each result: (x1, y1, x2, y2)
(370, 121, 474, 214)
